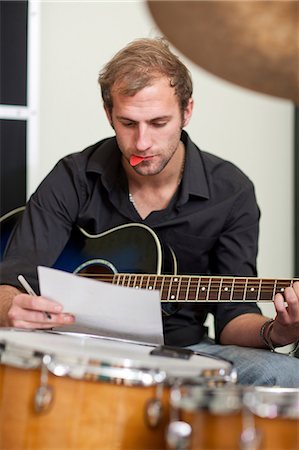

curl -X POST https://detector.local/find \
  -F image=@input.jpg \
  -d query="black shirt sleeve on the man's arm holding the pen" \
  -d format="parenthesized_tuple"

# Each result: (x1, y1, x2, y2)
(0, 157, 84, 292)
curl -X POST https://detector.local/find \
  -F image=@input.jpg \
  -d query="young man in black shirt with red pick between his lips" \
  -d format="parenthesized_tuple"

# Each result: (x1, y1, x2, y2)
(0, 39, 299, 387)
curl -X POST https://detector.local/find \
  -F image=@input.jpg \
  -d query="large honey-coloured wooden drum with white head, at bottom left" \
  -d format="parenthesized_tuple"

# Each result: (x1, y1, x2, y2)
(0, 329, 234, 450)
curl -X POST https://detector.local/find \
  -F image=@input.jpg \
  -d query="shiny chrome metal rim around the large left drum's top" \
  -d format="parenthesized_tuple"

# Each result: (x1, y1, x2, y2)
(0, 328, 236, 386)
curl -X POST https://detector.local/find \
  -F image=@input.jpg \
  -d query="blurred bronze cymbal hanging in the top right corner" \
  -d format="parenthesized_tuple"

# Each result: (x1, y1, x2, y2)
(147, 0, 299, 105)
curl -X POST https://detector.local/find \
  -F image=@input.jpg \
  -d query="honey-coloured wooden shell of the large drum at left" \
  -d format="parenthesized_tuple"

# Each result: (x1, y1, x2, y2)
(0, 366, 169, 450)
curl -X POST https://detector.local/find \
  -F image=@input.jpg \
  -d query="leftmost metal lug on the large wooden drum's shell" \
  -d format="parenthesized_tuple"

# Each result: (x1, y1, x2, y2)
(34, 355, 54, 413)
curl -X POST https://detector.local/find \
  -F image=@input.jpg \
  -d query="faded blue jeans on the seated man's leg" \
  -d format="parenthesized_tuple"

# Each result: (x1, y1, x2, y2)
(188, 338, 299, 388)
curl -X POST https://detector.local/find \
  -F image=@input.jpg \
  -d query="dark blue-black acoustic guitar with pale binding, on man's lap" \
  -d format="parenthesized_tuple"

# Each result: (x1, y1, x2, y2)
(0, 208, 298, 302)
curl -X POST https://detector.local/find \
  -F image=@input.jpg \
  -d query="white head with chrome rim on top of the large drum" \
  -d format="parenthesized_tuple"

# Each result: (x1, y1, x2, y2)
(0, 329, 233, 384)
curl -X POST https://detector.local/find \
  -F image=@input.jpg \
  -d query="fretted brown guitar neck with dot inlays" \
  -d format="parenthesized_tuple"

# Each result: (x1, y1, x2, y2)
(92, 273, 299, 302)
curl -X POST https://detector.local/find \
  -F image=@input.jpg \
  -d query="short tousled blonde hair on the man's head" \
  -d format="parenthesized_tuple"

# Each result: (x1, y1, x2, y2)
(98, 38, 193, 113)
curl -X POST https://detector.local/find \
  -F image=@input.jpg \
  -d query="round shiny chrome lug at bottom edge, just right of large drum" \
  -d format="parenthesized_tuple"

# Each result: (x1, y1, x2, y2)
(166, 420, 192, 450)
